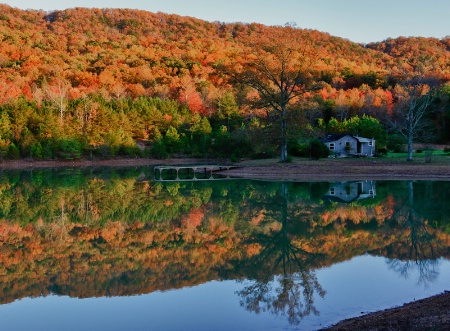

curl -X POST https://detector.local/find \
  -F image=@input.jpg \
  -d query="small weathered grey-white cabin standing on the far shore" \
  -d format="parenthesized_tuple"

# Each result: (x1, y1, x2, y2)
(322, 134, 375, 157)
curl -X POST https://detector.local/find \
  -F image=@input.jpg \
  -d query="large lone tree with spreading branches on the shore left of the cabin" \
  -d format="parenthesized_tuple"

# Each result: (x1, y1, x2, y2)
(225, 26, 316, 162)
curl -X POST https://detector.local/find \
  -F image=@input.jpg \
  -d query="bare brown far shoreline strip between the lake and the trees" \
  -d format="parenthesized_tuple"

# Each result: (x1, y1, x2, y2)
(0, 156, 450, 181)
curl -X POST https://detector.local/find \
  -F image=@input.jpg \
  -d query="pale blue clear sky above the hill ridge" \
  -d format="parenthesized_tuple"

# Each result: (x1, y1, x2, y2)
(2, 0, 450, 43)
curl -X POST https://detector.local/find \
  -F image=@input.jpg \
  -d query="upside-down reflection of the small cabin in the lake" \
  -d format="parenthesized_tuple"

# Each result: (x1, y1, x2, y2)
(324, 181, 376, 203)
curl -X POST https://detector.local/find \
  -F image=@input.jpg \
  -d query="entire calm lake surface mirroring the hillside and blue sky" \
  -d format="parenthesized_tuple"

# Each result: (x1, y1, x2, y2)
(0, 168, 450, 330)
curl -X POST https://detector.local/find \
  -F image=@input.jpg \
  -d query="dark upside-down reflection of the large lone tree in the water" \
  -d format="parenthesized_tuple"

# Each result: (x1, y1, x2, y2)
(230, 183, 325, 324)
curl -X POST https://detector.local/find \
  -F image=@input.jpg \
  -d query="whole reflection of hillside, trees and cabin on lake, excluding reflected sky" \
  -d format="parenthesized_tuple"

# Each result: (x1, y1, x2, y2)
(0, 168, 450, 325)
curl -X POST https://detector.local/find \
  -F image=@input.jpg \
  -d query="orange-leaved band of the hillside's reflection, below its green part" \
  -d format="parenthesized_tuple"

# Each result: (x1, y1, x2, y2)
(0, 220, 450, 308)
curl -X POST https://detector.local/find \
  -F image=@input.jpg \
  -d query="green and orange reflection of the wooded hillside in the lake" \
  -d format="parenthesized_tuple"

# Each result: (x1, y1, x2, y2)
(0, 177, 450, 302)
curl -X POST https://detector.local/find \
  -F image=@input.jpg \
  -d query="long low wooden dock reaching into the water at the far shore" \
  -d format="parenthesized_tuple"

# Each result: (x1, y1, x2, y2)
(154, 165, 237, 182)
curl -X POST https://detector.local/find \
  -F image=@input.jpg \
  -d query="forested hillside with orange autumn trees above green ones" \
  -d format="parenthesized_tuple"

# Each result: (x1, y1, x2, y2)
(0, 4, 450, 159)
